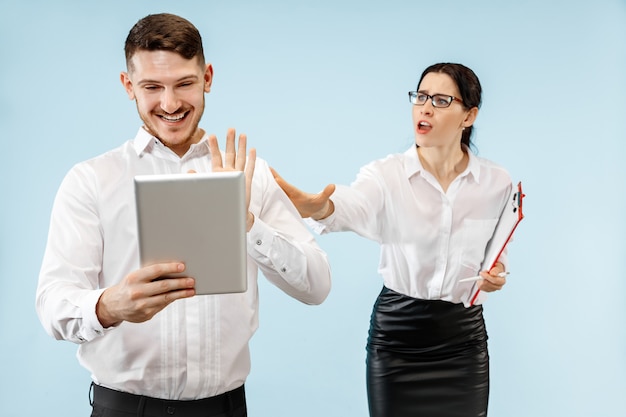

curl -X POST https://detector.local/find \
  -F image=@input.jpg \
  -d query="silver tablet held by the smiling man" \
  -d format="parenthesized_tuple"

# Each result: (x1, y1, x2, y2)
(135, 172, 247, 294)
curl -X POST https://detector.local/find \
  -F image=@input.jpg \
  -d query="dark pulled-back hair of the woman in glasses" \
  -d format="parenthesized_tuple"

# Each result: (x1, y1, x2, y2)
(417, 62, 482, 148)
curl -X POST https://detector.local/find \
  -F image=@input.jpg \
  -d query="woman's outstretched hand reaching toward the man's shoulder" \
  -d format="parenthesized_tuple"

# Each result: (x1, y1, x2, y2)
(270, 168, 335, 220)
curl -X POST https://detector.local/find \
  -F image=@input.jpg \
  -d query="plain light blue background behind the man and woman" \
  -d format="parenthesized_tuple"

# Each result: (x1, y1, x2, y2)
(0, 0, 626, 417)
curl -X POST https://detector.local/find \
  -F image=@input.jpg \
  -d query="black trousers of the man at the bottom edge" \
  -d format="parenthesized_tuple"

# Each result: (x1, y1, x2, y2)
(91, 383, 246, 417)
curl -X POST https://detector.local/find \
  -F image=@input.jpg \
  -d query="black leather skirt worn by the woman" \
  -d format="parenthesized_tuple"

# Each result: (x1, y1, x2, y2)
(367, 287, 489, 417)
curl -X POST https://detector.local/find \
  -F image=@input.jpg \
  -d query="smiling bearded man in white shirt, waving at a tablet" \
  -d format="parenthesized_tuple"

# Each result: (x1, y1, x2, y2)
(37, 14, 330, 417)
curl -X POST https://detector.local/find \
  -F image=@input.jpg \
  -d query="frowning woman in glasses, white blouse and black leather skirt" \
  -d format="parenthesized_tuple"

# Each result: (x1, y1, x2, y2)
(274, 63, 511, 417)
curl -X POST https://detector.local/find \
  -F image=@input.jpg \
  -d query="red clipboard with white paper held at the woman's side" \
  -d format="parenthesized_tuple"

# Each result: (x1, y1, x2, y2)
(470, 181, 526, 306)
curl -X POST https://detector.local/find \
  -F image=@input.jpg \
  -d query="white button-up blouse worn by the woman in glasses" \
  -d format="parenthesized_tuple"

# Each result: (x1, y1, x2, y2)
(307, 146, 512, 306)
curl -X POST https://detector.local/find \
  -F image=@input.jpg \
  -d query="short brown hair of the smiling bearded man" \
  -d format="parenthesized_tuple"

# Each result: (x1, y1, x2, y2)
(124, 13, 205, 70)
